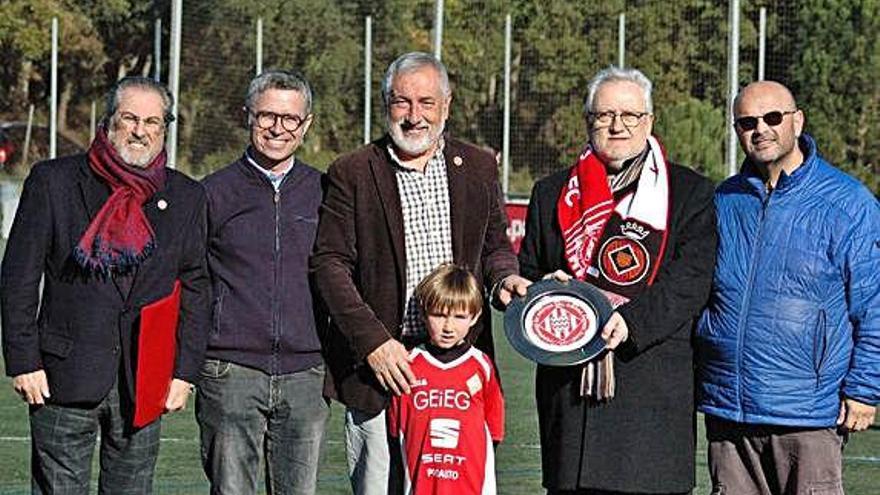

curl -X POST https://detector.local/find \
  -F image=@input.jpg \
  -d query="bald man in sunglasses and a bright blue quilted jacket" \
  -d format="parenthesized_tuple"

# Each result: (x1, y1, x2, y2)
(697, 82, 880, 494)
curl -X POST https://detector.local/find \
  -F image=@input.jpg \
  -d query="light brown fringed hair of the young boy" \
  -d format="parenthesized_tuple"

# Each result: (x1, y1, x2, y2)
(415, 263, 483, 315)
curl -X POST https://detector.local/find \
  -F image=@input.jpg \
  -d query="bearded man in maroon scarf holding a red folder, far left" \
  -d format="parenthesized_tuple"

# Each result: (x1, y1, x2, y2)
(0, 77, 210, 494)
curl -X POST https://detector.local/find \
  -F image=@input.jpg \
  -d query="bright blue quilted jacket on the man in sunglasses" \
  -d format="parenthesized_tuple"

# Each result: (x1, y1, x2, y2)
(696, 135, 880, 427)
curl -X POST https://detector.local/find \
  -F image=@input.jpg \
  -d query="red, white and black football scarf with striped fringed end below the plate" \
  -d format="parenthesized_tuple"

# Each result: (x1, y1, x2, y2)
(557, 136, 669, 400)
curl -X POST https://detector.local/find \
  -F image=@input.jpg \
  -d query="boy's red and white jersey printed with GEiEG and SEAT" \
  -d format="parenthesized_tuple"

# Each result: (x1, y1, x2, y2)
(388, 346, 504, 495)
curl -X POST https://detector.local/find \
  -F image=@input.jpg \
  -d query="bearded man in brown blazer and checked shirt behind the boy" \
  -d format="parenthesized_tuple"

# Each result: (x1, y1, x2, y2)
(310, 53, 529, 495)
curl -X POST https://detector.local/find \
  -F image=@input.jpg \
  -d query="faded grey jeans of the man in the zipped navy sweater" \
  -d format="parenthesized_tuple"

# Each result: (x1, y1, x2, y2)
(196, 359, 330, 495)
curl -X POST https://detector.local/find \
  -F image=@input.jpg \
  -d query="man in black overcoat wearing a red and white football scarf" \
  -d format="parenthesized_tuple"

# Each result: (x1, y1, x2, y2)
(519, 68, 716, 494)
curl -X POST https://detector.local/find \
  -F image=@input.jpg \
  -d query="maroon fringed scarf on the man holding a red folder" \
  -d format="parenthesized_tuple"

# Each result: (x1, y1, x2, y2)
(74, 129, 167, 275)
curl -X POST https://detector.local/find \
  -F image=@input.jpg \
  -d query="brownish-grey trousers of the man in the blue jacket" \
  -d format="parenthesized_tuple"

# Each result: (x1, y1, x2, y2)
(706, 415, 844, 495)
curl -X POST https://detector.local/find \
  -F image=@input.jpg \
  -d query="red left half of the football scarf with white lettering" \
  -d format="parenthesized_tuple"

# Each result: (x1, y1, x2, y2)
(557, 145, 614, 280)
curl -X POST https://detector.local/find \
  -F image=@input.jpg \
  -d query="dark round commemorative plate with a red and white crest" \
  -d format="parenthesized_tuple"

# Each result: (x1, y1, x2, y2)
(504, 280, 612, 366)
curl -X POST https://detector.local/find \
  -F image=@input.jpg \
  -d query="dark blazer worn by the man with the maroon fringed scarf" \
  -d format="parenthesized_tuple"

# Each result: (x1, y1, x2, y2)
(0, 155, 210, 404)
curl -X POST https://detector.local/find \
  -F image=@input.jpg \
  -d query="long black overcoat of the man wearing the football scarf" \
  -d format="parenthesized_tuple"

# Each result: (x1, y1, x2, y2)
(519, 164, 717, 493)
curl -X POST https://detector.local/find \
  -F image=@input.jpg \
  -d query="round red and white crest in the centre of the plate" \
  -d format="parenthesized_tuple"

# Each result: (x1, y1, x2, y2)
(525, 295, 596, 352)
